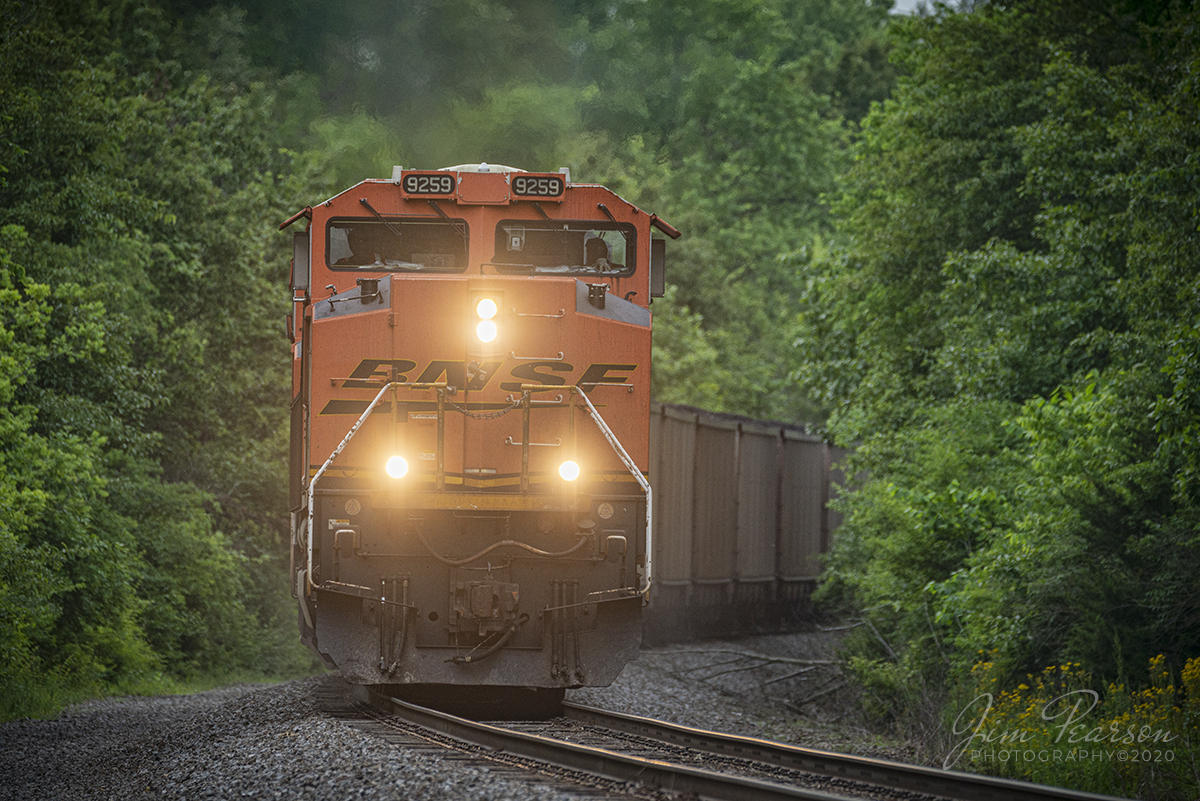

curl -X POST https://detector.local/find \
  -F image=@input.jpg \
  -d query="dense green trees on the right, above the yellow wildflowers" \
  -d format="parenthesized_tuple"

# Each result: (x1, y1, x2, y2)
(797, 0, 1200, 791)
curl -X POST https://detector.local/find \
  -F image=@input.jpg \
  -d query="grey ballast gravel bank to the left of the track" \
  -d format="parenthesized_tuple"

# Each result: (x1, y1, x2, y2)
(0, 677, 574, 801)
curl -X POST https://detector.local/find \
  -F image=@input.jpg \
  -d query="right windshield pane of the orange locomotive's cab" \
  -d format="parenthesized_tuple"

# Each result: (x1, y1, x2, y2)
(492, 219, 637, 276)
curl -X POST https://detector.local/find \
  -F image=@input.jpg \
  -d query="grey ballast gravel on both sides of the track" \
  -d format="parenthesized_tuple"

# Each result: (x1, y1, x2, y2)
(0, 636, 902, 801)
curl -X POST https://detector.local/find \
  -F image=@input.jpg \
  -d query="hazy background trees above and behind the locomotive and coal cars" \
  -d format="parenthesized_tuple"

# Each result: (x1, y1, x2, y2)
(223, 0, 894, 420)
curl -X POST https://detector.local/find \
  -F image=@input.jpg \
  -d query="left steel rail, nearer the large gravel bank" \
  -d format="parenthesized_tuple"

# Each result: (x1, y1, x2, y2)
(353, 685, 846, 801)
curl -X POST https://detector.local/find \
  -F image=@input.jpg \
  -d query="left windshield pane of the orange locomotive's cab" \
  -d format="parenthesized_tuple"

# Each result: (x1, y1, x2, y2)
(325, 218, 467, 272)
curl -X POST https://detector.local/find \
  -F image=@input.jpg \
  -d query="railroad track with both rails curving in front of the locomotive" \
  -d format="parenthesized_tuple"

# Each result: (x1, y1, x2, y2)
(353, 687, 1115, 801)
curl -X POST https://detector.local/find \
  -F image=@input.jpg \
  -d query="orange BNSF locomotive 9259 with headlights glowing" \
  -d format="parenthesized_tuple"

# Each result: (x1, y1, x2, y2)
(276, 164, 679, 698)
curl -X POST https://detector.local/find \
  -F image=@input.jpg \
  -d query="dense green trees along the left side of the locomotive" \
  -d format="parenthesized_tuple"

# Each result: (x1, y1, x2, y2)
(0, 2, 324, 715)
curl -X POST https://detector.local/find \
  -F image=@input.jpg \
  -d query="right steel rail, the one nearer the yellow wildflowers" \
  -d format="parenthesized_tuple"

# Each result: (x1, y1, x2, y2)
(563, 701, 1122, 801)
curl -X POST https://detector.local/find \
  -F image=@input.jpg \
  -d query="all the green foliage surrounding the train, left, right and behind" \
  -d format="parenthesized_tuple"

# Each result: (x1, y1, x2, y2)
(7, 0, 1200, 793)
